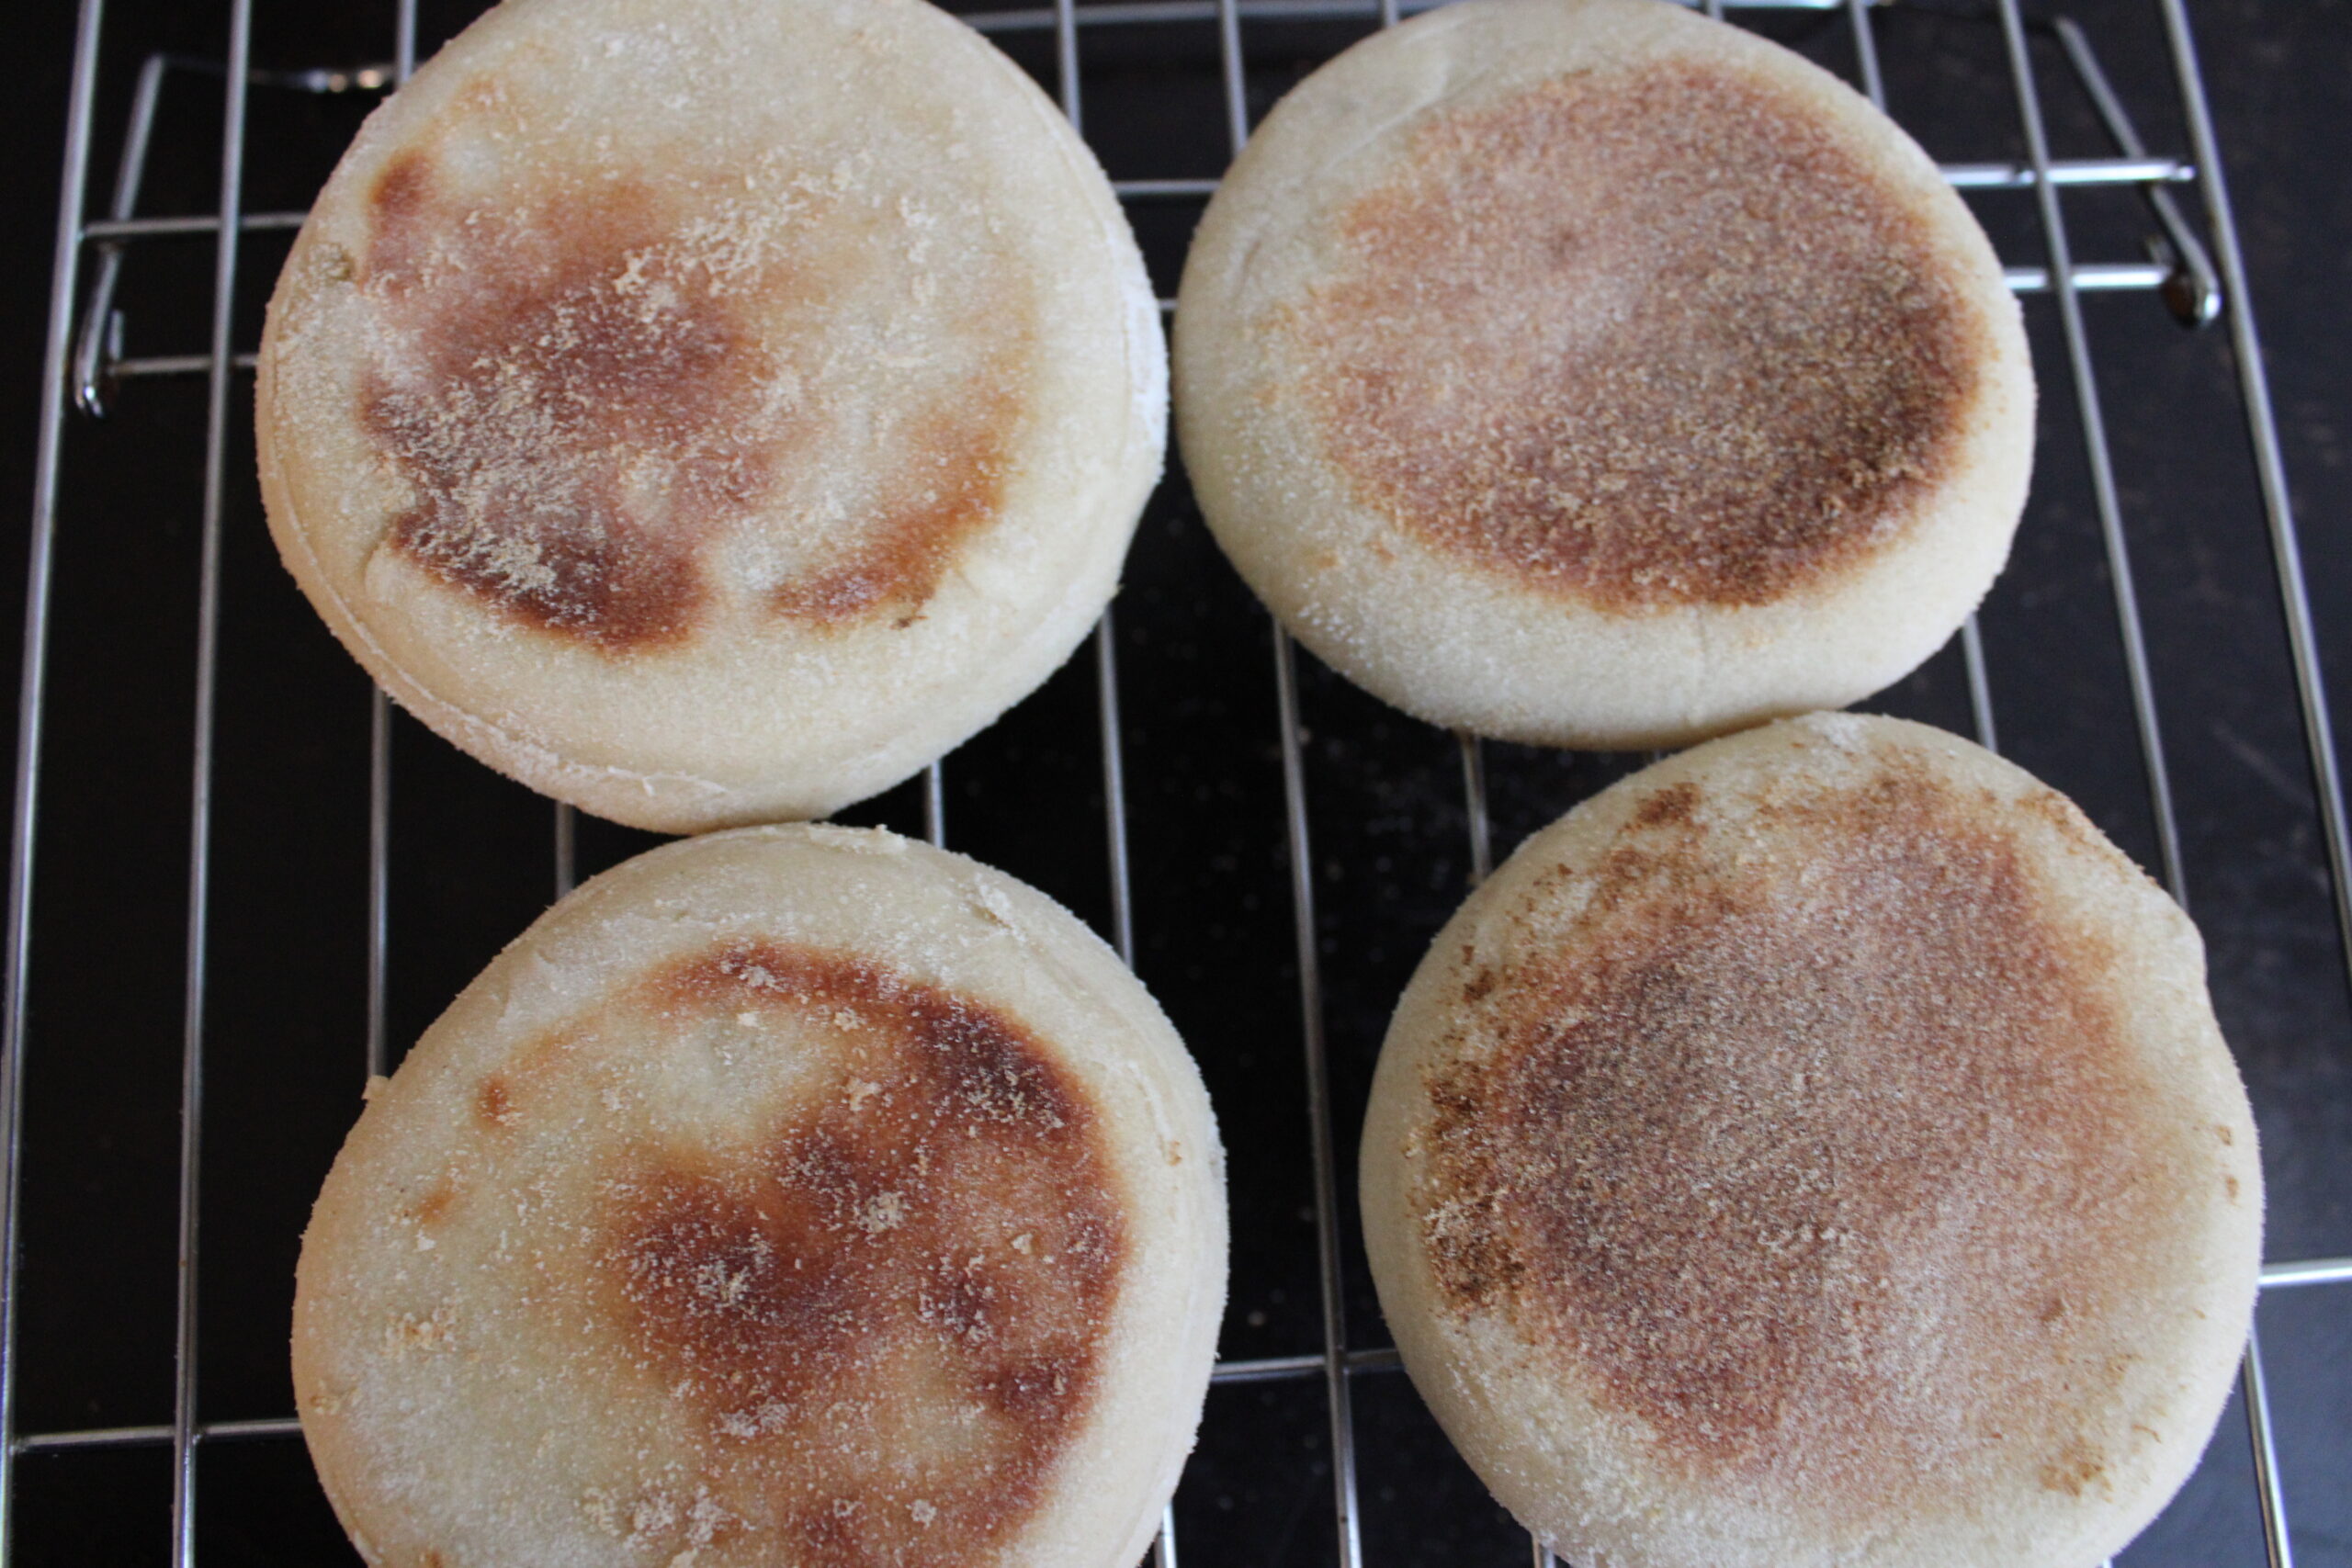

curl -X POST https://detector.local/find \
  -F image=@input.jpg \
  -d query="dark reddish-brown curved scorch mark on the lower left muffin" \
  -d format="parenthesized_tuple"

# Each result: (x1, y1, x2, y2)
(597, 942, 1126, 1568)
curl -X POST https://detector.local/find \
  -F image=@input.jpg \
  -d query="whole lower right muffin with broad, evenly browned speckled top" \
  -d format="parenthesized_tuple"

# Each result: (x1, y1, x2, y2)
(1362, 715, 2263, 1568)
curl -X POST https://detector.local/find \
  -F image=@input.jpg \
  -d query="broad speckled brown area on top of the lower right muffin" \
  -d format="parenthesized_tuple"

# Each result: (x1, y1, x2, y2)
(1423, 761, 2194, 1506)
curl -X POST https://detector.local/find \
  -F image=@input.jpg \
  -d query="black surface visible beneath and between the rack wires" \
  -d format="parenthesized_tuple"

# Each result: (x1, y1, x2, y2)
(0, 0, 2352, 1568)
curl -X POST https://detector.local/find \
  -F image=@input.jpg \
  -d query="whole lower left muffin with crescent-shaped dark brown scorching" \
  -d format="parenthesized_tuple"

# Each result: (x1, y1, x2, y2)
(294, 828, 1226, 1568)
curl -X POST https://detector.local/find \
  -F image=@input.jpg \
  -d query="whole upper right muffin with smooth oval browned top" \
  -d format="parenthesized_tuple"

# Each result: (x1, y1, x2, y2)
(1176, 0, 2034, 748)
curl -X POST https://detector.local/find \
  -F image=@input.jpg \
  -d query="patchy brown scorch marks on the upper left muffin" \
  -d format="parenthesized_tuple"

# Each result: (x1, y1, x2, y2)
(360, 151, 1033, 653)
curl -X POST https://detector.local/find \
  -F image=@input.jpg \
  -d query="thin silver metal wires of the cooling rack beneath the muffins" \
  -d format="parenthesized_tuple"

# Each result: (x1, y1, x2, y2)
(0, 0, 2352, 1568)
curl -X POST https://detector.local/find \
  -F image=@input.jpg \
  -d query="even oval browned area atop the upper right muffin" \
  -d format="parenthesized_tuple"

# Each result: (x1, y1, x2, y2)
(1284, 62, 1987, 614)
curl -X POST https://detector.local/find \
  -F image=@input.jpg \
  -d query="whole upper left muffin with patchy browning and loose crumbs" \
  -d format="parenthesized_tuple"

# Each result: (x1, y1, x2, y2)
(256, 0, 1167, 832)
